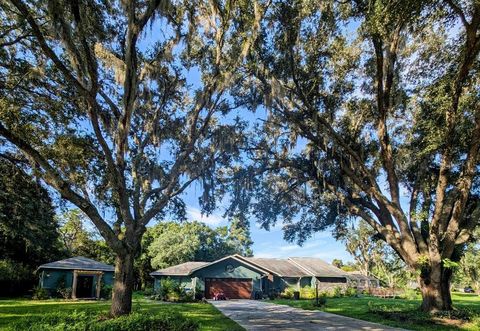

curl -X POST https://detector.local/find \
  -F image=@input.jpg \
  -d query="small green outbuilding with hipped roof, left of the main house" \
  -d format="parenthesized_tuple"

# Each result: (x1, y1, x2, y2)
(37, 256, 115, 299)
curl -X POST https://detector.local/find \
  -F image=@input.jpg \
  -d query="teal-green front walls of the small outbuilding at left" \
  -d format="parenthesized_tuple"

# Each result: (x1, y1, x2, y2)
(39, 269, 113, 297)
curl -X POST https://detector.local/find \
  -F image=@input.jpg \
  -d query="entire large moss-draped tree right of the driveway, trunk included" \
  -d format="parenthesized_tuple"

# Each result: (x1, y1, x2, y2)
(226, 0, 480, 311)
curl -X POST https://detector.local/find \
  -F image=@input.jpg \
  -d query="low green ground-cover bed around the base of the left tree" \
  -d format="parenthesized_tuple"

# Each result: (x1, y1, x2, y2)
(7, 311, 198, 331)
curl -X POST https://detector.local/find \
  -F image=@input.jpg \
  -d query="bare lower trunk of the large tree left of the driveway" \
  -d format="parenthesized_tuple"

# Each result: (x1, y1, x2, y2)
(110, 254, 134, 317)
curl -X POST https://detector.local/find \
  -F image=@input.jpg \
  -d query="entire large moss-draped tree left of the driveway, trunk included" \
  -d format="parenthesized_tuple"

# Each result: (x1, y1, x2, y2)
(0, 0, 263, 316)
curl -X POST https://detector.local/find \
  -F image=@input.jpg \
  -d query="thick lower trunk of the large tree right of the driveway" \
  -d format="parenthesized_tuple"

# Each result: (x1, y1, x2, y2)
(419, 265, 453, 312)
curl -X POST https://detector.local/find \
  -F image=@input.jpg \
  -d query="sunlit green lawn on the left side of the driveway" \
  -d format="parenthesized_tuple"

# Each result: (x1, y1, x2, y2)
(0, 295, 244, 331)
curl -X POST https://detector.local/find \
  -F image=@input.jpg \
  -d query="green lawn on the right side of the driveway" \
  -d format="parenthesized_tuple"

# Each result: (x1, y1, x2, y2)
(271, 293, 480, 331)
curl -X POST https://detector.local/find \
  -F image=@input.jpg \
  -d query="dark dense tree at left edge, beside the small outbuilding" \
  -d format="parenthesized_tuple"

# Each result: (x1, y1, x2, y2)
(0, 156, 61, 295)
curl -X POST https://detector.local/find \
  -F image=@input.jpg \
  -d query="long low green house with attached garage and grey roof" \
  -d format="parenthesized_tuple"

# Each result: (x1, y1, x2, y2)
(151, 255, 349, 299)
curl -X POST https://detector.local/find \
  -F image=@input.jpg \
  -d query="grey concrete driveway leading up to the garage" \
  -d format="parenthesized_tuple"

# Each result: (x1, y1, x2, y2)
(210, 300, 402, 331)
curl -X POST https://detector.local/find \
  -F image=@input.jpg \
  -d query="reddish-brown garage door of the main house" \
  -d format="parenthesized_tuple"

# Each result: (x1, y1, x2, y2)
(205, 278, 252, 299)
